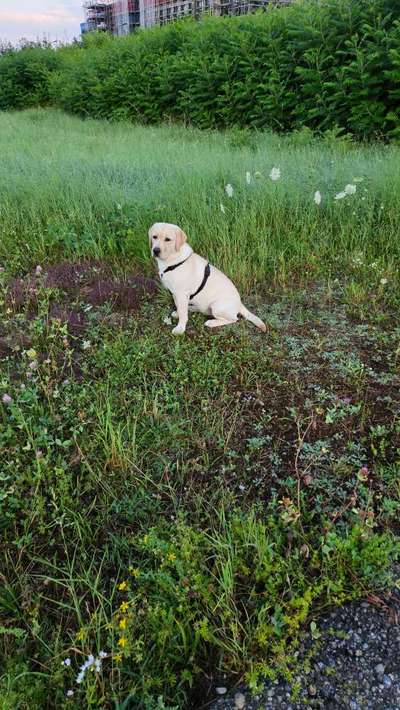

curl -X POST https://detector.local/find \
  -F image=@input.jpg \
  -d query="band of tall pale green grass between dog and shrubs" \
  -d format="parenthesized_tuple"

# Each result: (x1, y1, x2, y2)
(0, 110, 400, 288)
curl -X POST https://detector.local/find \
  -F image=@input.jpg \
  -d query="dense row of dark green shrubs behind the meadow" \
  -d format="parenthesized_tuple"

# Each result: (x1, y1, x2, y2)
(0, 0, 400, 137)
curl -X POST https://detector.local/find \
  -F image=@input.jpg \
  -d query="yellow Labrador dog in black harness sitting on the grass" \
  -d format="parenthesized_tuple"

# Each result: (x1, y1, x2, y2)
(149, 222, 266, 335)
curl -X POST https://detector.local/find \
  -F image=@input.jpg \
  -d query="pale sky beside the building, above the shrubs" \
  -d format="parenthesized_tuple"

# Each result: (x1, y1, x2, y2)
(0, 0, 84, 43)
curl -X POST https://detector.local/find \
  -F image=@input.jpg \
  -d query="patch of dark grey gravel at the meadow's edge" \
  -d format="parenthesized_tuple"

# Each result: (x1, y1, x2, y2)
(207, 591, 400, 710)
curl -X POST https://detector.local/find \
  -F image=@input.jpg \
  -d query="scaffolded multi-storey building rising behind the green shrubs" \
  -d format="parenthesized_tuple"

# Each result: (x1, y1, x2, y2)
(81, 0, 292, 35)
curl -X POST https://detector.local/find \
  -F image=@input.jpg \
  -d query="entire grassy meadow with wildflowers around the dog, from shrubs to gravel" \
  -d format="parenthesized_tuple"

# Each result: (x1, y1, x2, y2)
(0, 109, 400, 710)
